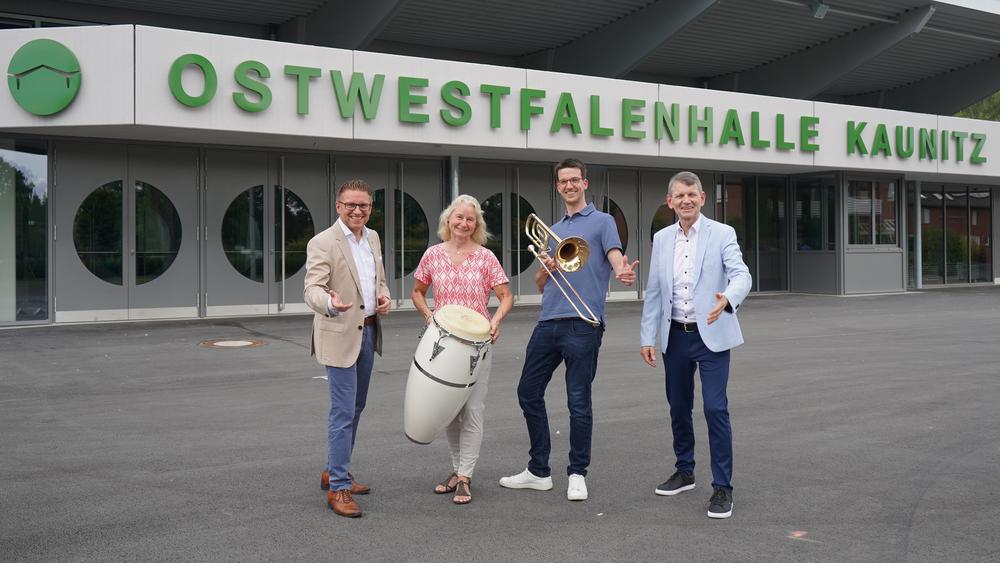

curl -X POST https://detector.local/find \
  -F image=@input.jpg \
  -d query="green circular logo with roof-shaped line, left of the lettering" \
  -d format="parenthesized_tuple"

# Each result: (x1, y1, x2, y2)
(7, 39, 81, 115)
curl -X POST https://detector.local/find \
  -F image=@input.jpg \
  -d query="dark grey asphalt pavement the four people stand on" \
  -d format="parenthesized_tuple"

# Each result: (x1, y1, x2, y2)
(0, 286, 1000, 562)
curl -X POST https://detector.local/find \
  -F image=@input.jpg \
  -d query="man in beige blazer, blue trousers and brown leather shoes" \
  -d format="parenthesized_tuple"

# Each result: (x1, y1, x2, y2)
(304, 180, 391, 518)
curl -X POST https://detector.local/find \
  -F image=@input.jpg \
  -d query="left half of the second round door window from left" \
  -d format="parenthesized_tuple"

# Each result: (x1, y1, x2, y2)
(222, 186, 264, 283)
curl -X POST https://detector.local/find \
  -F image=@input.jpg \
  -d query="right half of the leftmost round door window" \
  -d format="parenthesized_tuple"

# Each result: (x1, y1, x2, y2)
(135, 182, 181, 285)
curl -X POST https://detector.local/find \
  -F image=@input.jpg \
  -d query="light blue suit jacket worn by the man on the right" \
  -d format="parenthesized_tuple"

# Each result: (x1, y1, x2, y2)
(641, 216, 751, 352)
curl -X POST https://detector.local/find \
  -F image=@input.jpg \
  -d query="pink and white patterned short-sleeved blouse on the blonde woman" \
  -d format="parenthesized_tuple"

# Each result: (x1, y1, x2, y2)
(413, 243, 510, 320)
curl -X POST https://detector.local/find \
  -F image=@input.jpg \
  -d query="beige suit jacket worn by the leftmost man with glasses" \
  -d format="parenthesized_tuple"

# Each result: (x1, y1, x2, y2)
(303, 220, 389, 368)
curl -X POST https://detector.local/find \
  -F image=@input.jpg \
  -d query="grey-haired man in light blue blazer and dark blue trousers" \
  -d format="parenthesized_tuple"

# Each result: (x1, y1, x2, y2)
(640, 172, 751, 518)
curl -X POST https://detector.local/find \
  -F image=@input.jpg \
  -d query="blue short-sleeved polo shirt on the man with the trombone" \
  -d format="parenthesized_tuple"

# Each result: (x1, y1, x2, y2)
(539, 203, 622, 321)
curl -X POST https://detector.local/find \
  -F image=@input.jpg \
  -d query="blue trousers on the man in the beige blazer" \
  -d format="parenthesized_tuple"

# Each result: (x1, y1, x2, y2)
(326, 325, 375, 491)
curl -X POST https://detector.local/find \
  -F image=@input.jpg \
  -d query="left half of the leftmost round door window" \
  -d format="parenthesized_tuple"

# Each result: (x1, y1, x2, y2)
(73, 180, 122, 285)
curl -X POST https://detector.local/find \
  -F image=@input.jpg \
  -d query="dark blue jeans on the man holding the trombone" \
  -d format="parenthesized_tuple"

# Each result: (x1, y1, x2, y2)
(517, 319, 604, 477)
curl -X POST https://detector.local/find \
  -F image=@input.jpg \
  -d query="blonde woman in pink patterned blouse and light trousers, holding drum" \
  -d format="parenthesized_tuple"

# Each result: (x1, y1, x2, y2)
(412, 195, 514, 504)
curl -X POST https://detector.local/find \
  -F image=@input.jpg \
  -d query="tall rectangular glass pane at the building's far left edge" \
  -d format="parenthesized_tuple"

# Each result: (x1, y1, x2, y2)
(0, 139, 49, 323)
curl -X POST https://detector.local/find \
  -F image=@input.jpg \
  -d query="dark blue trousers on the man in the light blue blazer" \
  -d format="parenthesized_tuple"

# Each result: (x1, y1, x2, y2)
(663, 327, 733, 490)
